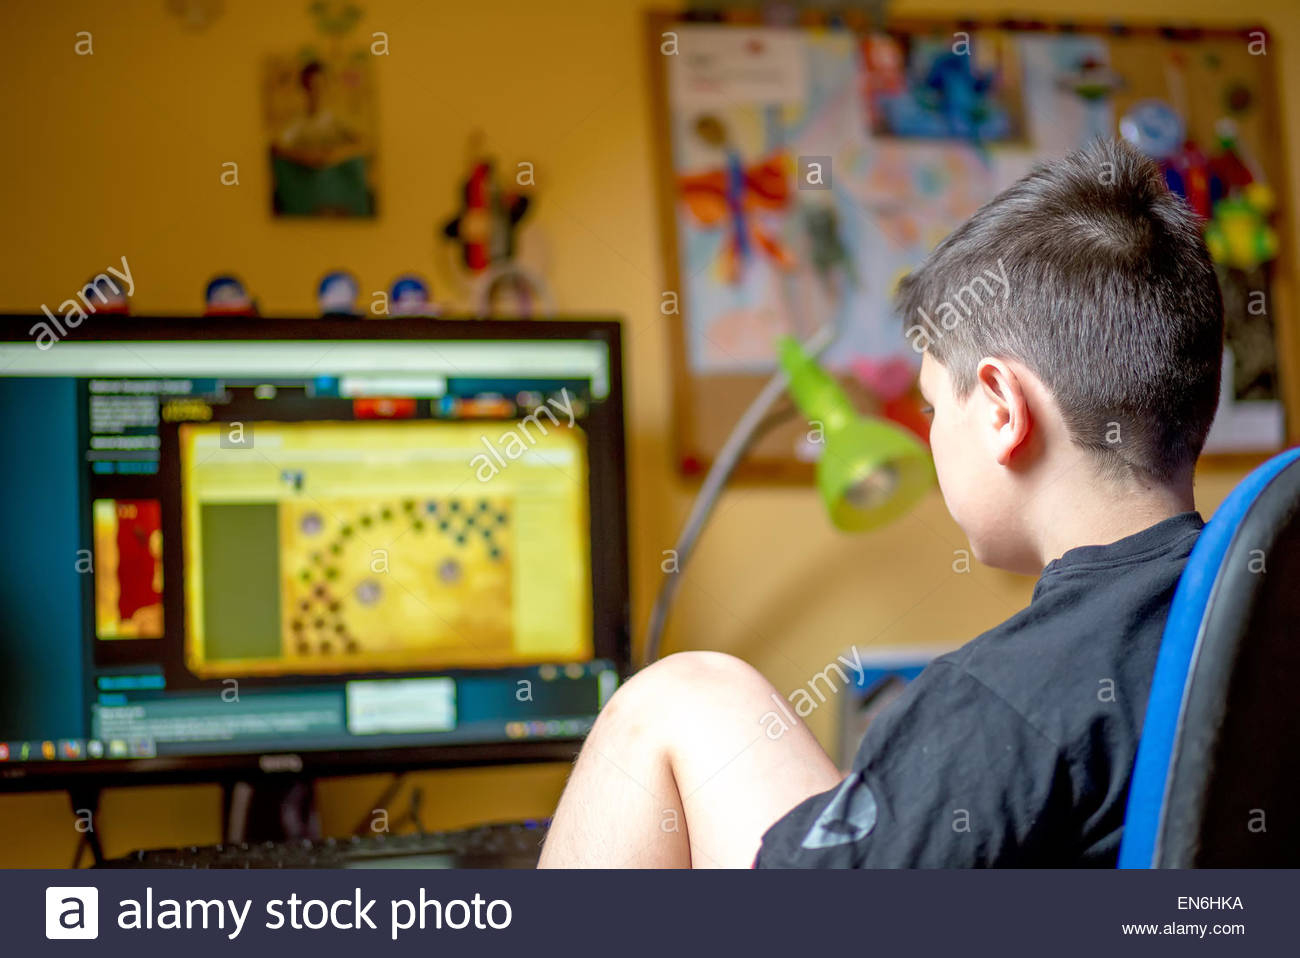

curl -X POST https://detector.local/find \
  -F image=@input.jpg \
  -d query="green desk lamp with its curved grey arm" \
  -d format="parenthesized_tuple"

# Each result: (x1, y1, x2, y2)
(645, 328, 935, 664)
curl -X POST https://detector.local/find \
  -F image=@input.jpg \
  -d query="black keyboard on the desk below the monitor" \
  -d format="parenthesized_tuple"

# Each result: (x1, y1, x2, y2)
(100, 820, 550, 868)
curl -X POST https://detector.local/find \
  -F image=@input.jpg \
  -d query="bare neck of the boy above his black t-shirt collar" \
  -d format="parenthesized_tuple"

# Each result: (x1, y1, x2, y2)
(1037, 474, 1196, 568)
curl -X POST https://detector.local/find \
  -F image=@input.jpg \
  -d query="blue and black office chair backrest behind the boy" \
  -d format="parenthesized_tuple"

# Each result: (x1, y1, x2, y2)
(1119, 448, 1300, 868)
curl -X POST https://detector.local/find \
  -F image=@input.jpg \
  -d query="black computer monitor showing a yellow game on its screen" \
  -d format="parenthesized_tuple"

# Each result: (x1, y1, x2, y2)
(0, 316, 629, 789)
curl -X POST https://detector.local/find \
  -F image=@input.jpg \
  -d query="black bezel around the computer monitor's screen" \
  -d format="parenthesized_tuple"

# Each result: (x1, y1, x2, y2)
(0, 313, 632, 792)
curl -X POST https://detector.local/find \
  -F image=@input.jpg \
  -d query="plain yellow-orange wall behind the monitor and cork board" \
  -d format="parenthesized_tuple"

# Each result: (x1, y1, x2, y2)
(0, 0, 1300, 866)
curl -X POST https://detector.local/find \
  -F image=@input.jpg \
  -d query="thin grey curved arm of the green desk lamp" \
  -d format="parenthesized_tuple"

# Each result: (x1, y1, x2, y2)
(642, 325, 836, 666)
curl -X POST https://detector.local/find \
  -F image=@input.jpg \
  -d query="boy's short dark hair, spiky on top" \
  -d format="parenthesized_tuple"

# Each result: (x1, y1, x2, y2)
(896, 140, 1223, 482)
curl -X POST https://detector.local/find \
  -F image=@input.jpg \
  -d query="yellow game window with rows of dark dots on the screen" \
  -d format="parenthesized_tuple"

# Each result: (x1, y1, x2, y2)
(179, 420, 593, 679)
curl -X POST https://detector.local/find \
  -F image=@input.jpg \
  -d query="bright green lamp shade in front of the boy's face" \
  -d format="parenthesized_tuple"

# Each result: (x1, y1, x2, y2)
(777, 337, 935, 532)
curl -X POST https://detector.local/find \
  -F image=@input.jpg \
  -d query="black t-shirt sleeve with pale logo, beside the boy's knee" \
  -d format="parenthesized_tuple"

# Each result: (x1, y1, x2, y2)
(755, 659, 1070, 868)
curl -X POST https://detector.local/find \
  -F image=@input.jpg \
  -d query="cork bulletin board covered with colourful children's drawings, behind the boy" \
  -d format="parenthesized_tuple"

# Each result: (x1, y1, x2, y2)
(647, 10, 1300, 481)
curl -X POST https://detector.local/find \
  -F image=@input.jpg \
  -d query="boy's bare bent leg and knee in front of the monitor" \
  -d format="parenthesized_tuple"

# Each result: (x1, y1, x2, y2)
(540, 653, 842, 868)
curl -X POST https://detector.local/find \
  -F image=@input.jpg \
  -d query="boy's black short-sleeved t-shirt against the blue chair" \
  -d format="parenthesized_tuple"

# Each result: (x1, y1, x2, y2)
(755, 512, 1203, 868)
